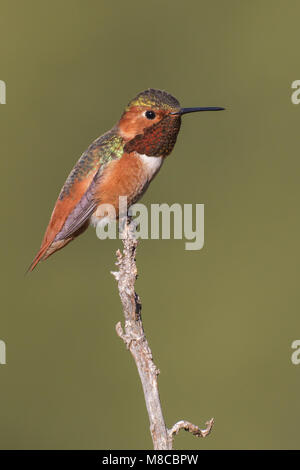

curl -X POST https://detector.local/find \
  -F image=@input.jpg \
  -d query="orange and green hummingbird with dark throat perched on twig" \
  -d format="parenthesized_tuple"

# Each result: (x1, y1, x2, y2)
(28, 88, 224, 271)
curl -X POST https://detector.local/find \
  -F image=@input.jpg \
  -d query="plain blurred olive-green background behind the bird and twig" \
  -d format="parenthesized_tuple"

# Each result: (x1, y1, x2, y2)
(0, 0, 300, 449)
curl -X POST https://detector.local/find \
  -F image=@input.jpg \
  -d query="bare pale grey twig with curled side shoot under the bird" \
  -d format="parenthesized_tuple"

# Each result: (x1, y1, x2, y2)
(112, 218, 213, 450)
